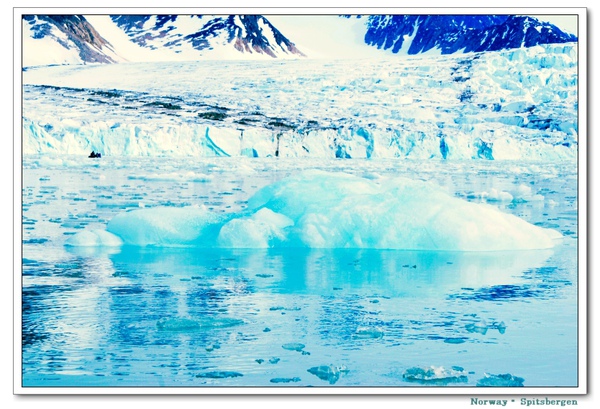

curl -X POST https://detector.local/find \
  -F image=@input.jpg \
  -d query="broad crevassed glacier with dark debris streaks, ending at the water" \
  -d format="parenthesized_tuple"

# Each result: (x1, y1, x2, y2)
(22, 44, 579, 160)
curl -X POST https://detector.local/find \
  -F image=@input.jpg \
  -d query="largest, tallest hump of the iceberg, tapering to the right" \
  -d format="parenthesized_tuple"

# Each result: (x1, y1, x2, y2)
(248, 170, 560, 251)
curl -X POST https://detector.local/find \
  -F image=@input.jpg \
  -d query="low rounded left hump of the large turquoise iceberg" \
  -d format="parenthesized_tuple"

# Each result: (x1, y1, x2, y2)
(107, 207, 223, 247)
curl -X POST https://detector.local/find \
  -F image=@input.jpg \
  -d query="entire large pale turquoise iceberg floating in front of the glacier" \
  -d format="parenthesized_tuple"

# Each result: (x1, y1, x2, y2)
(69, 170, 560, 251)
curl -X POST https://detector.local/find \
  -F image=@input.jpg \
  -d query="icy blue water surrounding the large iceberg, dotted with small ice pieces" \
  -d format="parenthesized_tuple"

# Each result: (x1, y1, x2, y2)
(22, 157, 578, 387)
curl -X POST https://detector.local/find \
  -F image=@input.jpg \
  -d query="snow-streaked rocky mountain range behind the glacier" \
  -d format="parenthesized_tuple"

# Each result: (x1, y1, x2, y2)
(23, 15, 577, 67)
